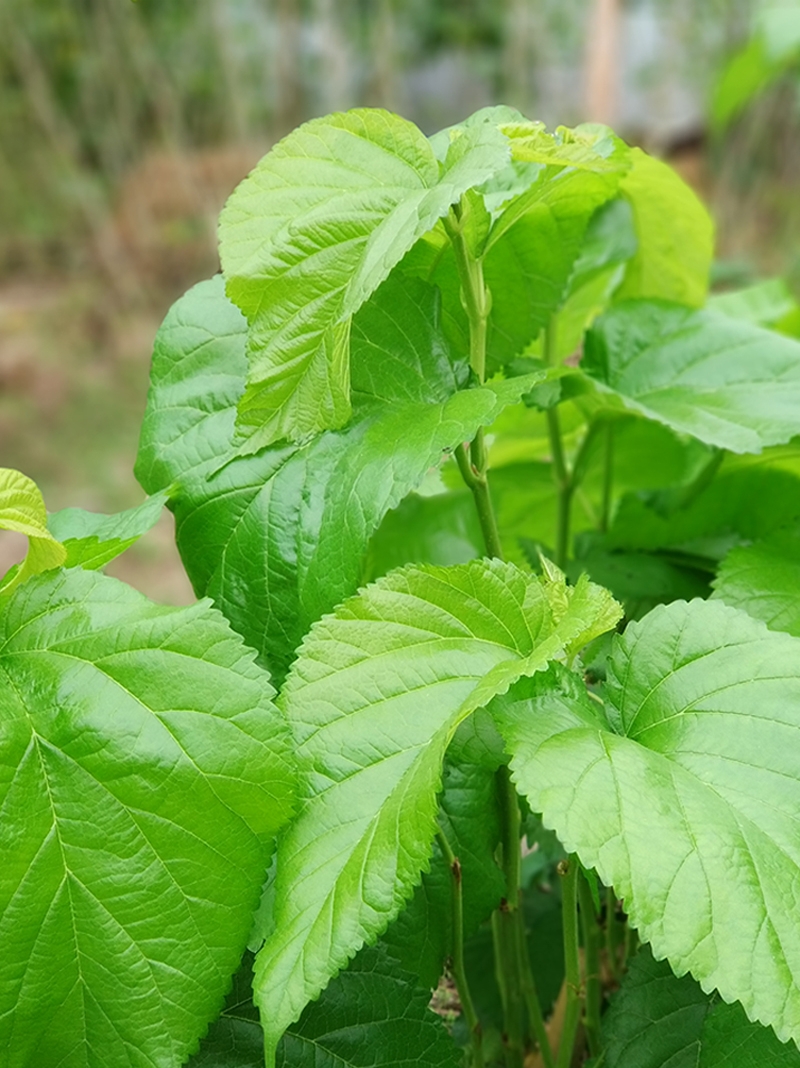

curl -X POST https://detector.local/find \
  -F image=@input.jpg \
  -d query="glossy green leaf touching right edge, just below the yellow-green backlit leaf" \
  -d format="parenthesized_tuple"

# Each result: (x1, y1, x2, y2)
(582, 300, 800, 453)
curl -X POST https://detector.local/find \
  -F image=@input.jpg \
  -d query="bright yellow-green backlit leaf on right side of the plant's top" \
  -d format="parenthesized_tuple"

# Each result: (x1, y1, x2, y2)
(617, 148, 713, 308)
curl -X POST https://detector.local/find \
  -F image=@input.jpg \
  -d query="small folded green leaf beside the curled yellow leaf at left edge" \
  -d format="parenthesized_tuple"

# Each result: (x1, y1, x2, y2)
(47, 490, 169, 570)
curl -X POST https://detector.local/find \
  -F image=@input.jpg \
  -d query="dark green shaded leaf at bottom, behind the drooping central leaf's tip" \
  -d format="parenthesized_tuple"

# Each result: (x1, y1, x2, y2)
(189, 946, 459, 1068)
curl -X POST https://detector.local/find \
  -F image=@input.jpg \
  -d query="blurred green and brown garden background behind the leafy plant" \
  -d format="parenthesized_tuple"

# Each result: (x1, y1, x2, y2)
(0, 0, 800, 602)
